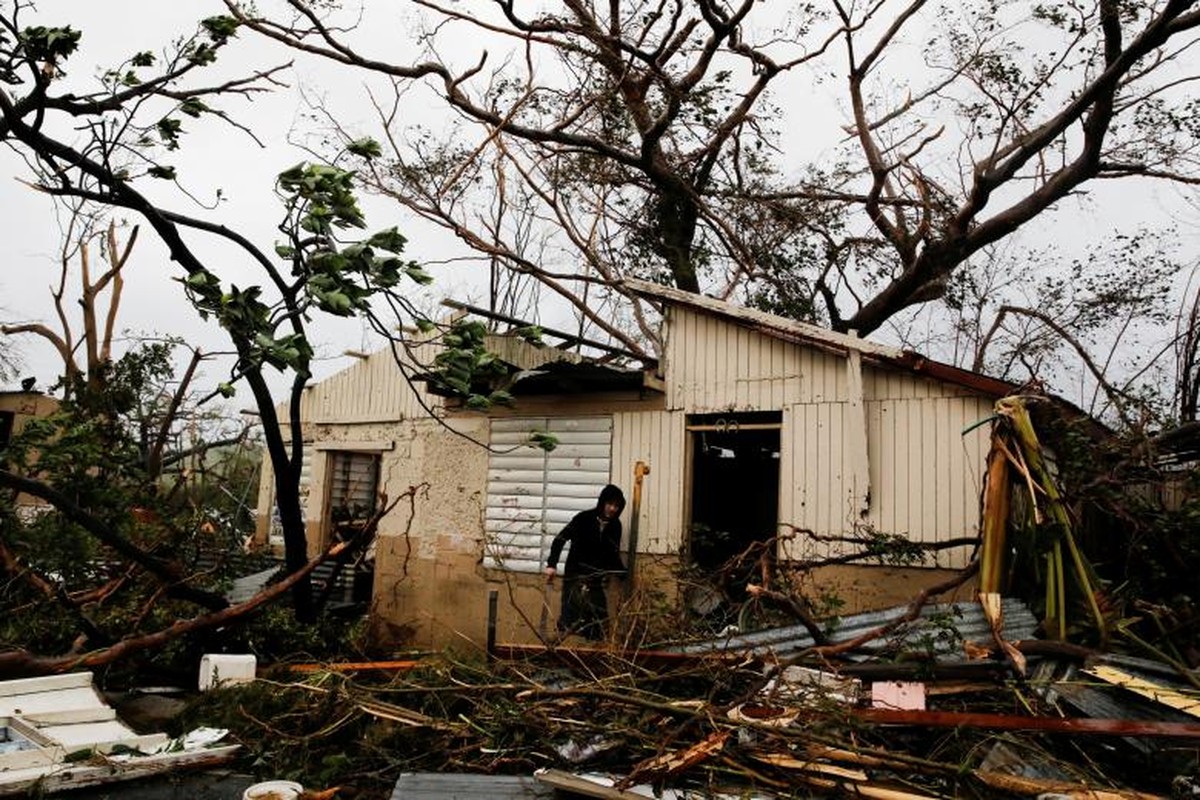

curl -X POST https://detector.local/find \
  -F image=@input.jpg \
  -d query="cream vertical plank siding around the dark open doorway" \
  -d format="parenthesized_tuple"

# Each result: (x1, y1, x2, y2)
(657, 306, 992, 566)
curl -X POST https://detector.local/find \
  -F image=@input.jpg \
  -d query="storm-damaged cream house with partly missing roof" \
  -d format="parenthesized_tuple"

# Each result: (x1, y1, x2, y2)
(259, 282, 1015, 646)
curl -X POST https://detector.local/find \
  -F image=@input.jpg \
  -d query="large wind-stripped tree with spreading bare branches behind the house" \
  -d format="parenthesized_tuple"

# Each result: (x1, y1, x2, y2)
(226, 0, 1200, 348)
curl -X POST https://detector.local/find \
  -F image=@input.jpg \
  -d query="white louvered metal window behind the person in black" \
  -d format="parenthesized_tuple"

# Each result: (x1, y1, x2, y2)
(484, 416, 612, 572)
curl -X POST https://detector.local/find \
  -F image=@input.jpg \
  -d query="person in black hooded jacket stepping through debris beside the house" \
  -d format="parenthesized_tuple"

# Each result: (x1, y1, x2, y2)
(546, 483, 625, 639)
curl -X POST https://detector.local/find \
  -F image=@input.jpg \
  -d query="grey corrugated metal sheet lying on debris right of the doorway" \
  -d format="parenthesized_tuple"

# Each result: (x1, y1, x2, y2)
(677, 597, 1038, 661)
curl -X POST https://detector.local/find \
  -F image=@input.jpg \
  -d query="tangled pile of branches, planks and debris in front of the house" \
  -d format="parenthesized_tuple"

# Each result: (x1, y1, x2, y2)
(180, 603, 1200, 800)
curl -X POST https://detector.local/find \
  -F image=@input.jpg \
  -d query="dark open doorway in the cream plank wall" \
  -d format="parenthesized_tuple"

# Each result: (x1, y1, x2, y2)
(688, 411, 781, 575)
